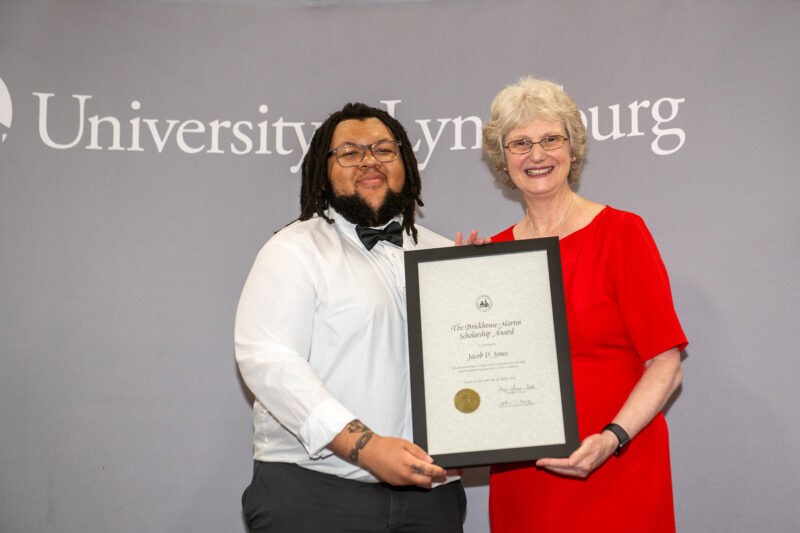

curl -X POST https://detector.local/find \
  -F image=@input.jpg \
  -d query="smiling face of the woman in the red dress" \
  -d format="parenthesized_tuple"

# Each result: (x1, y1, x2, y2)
(503, 120, 570, 196)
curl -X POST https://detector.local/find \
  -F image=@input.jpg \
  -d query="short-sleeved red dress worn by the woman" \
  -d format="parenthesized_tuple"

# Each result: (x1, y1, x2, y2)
(489, 207, 687, 533)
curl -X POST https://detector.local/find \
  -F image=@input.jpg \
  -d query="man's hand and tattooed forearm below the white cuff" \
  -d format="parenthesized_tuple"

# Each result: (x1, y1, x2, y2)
(328, 420, 445, 488)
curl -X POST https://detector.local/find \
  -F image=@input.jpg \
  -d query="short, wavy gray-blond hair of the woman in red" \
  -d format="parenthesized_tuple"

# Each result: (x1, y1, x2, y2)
(483, 76, 586, 189)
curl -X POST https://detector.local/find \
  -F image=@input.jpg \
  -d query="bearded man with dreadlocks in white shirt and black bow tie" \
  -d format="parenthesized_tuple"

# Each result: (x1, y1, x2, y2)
(235, 104, 465, 533)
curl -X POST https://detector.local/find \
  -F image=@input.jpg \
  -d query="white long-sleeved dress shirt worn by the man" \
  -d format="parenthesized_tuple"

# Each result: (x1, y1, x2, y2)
(234, 210, 453, 482)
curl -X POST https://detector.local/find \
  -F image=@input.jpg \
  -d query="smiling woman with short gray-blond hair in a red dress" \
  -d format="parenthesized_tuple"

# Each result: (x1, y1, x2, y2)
(483, 78, 687, 533)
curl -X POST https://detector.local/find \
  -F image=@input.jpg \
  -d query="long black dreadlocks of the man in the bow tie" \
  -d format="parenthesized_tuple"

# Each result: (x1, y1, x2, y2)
(298, 102, 423, 242)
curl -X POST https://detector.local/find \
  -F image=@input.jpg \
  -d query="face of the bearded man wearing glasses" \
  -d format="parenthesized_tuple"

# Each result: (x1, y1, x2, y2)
(328, 117, 406, 213)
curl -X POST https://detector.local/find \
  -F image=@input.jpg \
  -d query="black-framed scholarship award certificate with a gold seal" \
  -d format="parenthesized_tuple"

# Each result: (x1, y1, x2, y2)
(405, 237, 579, 468)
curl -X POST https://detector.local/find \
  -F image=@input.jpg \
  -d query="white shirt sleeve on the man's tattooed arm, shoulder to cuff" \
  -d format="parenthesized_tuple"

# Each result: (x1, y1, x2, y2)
(234, 239, 356, 458)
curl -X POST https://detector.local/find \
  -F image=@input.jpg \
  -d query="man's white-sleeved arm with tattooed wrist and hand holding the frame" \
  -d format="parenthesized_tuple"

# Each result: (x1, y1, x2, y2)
(235, 235, 444, 487)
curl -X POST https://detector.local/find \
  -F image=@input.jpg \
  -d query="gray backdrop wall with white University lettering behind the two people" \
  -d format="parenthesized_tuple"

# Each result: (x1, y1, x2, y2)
(0, 0, 800, 533)
